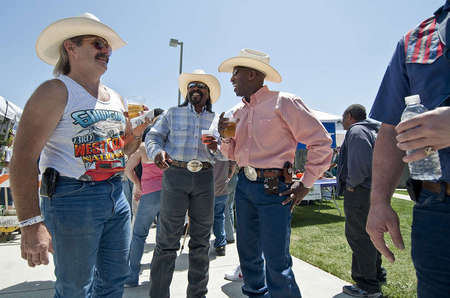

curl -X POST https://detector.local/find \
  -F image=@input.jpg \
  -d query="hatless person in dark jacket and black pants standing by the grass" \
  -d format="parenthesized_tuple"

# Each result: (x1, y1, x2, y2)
(336, 104, 386, 298)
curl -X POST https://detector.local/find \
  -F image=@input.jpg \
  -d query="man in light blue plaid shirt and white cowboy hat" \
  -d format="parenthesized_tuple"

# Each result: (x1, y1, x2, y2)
(145, 70, 220, 298)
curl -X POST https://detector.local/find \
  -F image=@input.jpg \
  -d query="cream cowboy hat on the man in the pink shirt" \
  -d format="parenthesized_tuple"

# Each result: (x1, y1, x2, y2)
(219, 49, 281, 83)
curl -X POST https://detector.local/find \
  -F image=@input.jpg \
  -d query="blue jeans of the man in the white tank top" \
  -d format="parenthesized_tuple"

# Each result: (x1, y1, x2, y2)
(41, 177, 130, 298)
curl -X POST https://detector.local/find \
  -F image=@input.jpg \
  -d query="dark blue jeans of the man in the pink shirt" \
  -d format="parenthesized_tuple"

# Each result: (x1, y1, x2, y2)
(236, 171, 301, 298)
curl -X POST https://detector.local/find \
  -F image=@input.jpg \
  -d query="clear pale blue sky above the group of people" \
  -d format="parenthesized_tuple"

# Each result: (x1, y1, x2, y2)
(0, 0, 445, 115)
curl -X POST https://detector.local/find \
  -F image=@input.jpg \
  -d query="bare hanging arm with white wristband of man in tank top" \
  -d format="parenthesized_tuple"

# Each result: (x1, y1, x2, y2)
(10, 80, 67, 267)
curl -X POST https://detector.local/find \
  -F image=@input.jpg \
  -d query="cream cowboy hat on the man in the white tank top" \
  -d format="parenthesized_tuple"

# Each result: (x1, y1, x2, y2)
(36, 12, 127, 65)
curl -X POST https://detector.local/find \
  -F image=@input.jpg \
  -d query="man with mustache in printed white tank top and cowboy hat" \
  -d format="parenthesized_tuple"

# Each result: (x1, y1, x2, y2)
(10, 13, 143, 297)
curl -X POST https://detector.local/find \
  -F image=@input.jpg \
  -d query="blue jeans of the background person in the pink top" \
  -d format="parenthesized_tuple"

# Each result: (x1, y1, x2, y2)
(127, 191, 161, 284)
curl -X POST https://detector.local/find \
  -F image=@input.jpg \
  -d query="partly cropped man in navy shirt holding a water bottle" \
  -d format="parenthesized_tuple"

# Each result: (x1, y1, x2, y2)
(367, 1, 450, 298)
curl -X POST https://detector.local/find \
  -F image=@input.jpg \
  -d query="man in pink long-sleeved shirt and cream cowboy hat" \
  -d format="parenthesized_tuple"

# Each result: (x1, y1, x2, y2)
(219, 49, 332, 298)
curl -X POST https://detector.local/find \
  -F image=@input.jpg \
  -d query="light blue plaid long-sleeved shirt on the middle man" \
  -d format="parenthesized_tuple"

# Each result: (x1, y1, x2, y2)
(145, 103, 221, 163)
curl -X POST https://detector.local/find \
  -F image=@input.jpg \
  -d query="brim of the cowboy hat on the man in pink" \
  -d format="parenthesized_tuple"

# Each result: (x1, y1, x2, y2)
(219, 56, 281, 83)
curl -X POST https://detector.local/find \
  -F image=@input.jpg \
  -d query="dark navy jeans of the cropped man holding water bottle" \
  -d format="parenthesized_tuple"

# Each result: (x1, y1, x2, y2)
(411, 190, 450, 298)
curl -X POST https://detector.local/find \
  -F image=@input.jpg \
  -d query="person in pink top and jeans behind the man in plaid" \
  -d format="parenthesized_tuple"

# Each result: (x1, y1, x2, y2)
(125, 111, 163, 287)
